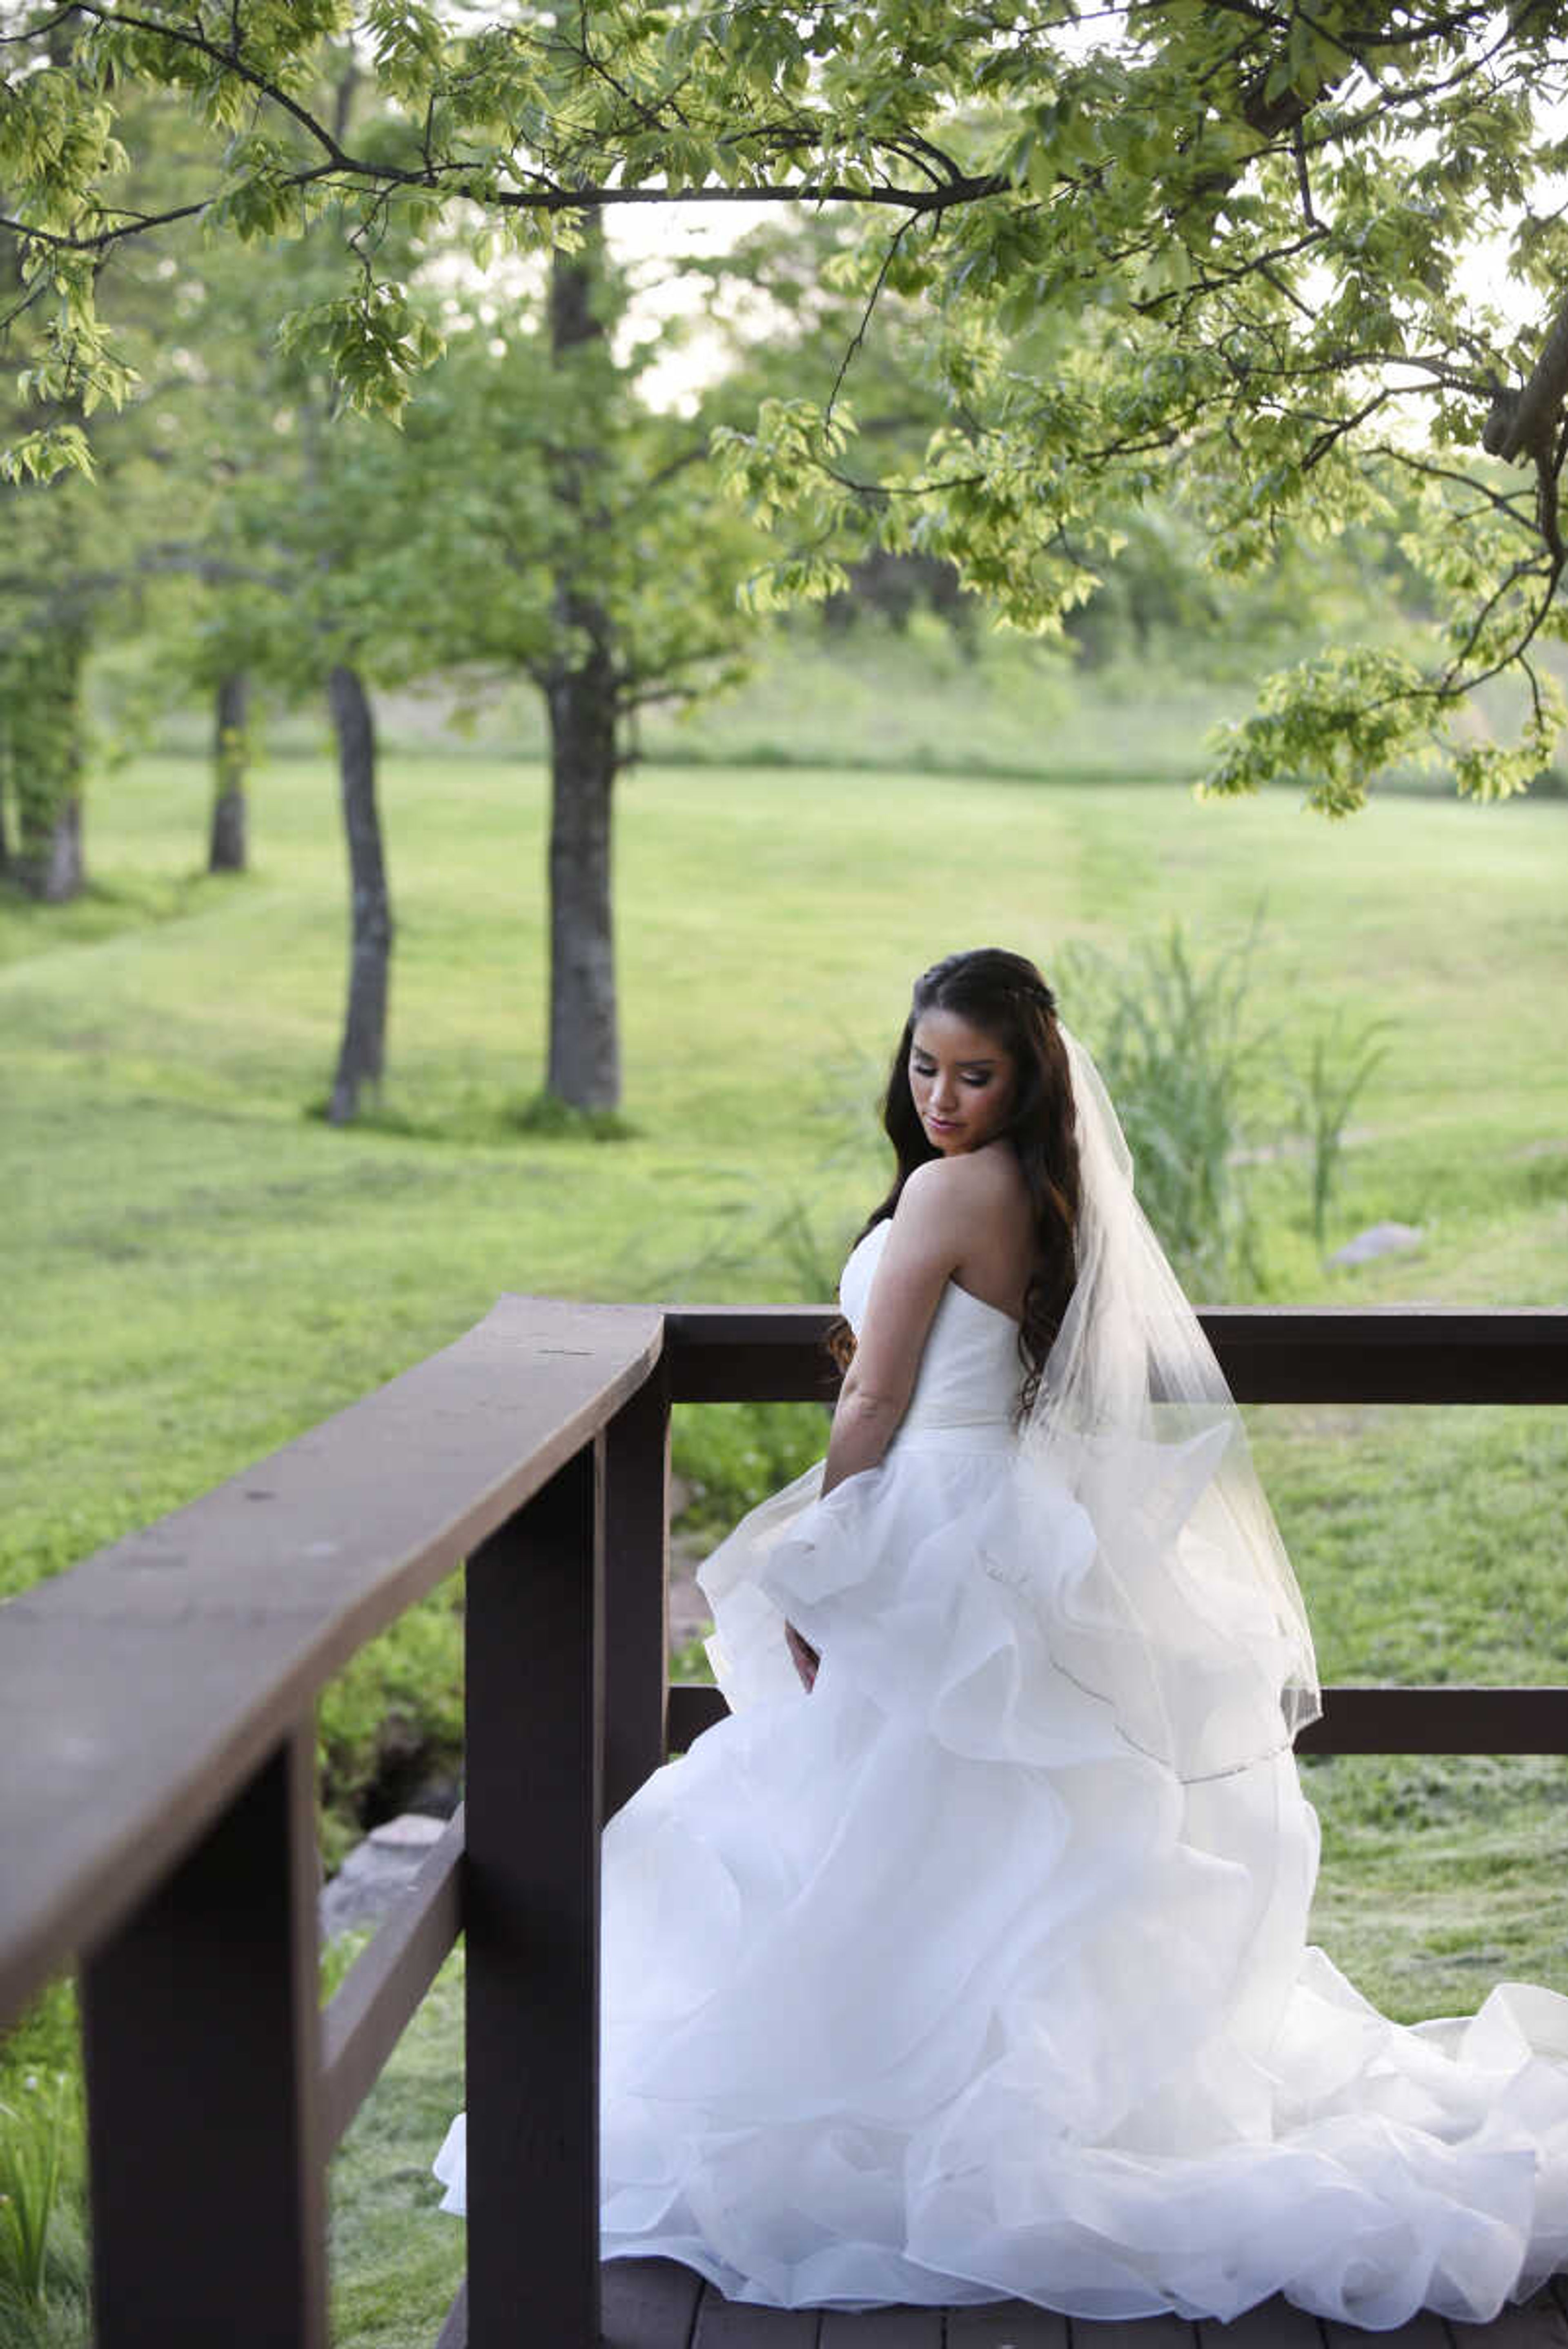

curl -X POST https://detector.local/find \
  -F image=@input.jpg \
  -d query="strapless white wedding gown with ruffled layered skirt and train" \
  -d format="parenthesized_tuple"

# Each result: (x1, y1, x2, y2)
(435, 1222, 1568, 2328)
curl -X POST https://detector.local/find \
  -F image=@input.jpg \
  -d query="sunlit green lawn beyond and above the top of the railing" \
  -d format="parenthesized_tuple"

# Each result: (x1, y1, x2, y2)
(0, 759, 1568, 1590)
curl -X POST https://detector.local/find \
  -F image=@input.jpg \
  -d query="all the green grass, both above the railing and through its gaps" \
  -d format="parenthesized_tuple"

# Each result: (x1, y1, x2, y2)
(0, 723, 1568, 2349)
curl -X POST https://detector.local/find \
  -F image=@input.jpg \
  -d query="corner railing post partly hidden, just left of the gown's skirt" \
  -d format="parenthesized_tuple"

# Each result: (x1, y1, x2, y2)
(604, 1363, 670, 1818)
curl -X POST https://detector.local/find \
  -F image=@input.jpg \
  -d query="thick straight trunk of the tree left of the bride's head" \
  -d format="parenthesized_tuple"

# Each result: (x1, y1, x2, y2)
(546, 234, 621, 1109)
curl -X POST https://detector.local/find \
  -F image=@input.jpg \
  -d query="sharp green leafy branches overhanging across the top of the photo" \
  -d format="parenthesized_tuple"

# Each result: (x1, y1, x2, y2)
(0, 0, 1568, 813)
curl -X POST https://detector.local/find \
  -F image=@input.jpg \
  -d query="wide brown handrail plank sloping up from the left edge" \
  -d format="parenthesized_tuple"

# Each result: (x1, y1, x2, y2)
(0, 1297, 663, 2022)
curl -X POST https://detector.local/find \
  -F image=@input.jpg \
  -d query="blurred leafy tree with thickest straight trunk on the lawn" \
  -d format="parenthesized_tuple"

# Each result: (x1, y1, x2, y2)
(367, 223, 762, 1120)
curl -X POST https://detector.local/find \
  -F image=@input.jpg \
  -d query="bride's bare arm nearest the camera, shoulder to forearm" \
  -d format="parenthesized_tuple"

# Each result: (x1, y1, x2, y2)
(823, 1158, 973, 1492)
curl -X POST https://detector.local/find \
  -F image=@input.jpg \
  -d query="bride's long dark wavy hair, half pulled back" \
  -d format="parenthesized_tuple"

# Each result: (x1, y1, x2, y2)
(828, 946, 1079, 1419)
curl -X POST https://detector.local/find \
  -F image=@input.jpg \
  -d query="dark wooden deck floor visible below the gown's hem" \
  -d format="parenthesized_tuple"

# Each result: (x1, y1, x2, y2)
(592, 2260, 1568, 2349)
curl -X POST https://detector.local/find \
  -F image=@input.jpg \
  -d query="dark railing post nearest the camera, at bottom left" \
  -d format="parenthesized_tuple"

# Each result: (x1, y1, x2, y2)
(82, 1717, 327, 2349)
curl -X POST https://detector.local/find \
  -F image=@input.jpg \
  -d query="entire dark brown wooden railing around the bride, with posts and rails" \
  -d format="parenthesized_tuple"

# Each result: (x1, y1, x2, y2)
(0, 1297, 1568, 2349)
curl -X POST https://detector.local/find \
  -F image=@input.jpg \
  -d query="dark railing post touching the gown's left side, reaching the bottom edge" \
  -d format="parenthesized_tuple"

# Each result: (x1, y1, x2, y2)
(463, 1438, 604, 2349)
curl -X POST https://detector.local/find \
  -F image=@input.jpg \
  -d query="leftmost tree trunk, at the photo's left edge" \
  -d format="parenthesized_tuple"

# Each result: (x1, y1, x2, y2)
(7, 627, 87, 904)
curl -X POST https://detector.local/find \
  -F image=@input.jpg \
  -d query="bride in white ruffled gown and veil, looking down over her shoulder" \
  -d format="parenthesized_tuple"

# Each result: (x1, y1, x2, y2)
(435, 949, 1568, 2328)
